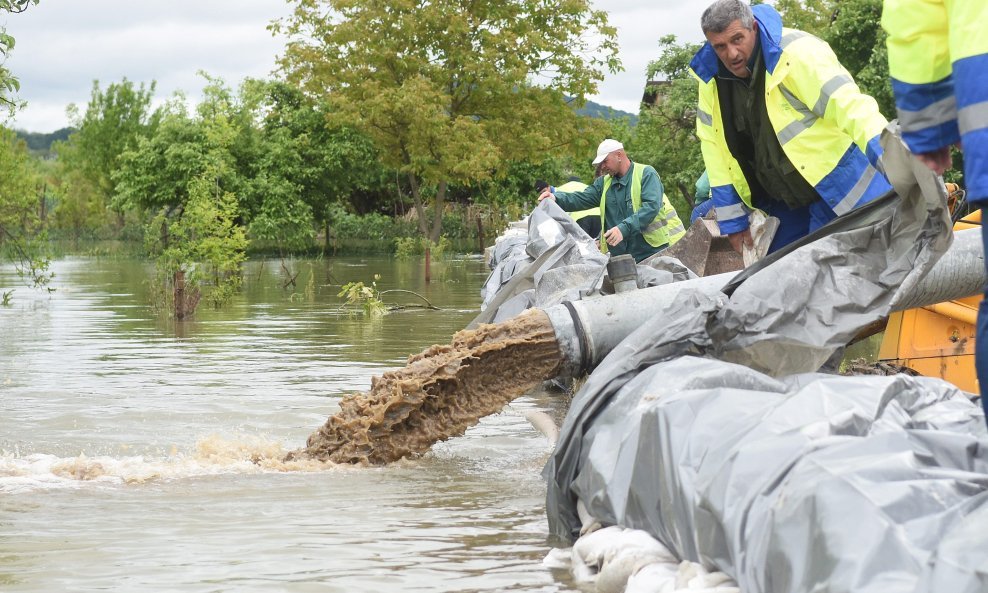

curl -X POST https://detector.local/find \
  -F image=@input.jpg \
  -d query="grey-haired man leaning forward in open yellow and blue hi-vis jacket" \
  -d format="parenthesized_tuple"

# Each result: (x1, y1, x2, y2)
(690, 0, 891, 251)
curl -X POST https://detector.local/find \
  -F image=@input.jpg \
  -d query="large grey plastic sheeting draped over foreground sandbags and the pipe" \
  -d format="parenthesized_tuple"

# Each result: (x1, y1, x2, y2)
(545, 126, 988, 593)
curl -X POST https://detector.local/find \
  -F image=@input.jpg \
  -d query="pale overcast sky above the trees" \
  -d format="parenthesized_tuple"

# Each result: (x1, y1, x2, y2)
(3, 0, 708, 132)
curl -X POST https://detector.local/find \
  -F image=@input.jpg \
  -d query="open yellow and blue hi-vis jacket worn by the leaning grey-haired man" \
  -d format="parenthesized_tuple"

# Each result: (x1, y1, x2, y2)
(690, 4, 891, 234)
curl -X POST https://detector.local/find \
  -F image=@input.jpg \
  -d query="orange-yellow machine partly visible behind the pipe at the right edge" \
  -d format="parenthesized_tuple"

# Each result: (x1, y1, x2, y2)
(878, 200, 982, 393)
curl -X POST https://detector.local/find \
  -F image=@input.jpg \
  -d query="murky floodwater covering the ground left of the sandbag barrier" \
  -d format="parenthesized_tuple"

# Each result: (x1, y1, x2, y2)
(0, 253, 576, 592)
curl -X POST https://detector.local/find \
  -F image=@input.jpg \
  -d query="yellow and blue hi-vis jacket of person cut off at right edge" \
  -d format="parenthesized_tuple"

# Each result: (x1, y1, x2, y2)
(882, 0, 988, 202)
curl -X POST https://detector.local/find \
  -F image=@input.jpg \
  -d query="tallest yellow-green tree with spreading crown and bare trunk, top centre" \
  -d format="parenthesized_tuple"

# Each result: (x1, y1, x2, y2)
(274, 0, 620, 242)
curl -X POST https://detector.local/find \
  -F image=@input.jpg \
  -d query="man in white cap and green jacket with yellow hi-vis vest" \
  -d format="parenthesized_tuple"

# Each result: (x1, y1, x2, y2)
(539, 138, 686, 261)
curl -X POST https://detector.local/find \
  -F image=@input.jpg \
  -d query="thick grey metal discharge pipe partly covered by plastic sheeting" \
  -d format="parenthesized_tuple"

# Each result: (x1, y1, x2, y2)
(545, 228, 988, 377)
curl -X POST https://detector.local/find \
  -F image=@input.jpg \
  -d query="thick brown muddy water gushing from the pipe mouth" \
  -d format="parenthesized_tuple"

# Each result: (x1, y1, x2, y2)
(289, 309, 560, 464)
